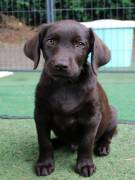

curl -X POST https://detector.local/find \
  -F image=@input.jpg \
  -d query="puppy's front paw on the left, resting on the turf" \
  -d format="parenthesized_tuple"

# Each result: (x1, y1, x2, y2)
(35, 160, 54, 176)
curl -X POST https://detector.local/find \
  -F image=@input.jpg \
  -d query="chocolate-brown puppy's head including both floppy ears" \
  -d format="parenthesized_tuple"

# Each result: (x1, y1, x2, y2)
(24, 20, 110, 79)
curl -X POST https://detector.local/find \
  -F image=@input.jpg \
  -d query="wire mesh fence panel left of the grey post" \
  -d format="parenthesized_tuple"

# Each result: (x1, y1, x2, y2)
(0, 0, 46, 71)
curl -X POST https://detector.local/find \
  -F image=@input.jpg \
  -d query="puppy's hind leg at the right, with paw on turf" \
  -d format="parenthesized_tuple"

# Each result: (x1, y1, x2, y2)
(94, 106, 117, 156)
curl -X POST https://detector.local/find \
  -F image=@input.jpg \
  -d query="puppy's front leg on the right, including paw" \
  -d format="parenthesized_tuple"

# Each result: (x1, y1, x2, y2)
(75, 113, 100, 177)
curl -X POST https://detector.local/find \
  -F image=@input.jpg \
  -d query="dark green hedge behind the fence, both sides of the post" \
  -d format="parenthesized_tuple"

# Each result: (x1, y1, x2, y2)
(0, 0, 135, 25)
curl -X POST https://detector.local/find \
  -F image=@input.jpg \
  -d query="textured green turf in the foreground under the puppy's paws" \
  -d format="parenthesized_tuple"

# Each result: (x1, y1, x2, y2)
(0, 120, 135, 180)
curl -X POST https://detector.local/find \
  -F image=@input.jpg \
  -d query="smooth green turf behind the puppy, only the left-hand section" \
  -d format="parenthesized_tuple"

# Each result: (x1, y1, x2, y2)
(0, 72, 40, 116)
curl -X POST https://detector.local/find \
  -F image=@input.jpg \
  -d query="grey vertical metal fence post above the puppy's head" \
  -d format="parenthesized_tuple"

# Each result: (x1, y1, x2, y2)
(46, 0, 54, 23)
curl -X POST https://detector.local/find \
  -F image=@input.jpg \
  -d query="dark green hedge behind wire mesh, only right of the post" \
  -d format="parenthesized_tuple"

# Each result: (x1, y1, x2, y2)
(54, 0, 135, 21)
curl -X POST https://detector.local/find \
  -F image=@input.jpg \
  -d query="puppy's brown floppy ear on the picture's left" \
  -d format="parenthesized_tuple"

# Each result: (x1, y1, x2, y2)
(24, 24, 49, 69)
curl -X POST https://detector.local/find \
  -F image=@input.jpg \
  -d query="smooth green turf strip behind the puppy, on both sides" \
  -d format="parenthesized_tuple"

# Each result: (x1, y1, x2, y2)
(0, 72, 135, 121)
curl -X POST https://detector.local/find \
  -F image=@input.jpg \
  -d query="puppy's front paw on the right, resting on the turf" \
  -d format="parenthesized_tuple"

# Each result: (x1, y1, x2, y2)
(75, 160, 96, 177)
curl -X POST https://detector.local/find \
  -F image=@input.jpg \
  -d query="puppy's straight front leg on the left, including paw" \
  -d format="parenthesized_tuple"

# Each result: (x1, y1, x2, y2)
(35, 107, 54, 176)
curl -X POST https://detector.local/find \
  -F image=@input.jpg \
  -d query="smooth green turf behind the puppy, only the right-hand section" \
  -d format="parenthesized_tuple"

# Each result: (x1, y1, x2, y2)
(99, 73, 135, 121)
